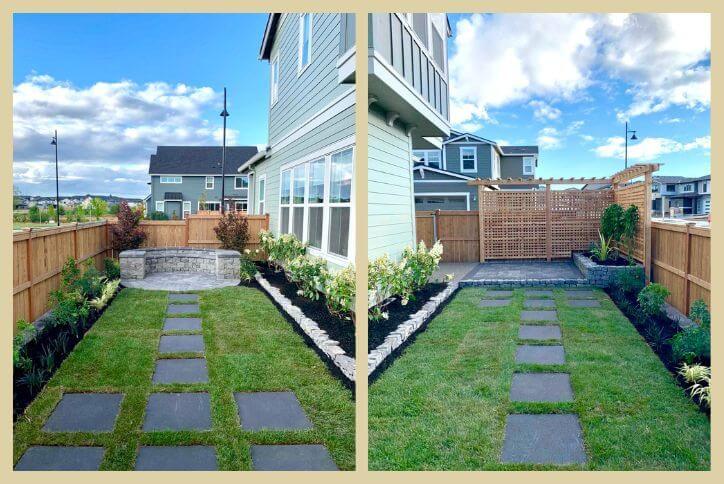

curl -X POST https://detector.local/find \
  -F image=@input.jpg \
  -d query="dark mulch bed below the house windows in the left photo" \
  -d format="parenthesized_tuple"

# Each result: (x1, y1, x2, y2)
(257, 263, 355, 358)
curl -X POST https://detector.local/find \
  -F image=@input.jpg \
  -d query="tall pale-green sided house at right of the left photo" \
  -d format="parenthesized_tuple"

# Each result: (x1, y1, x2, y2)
(238, 13, 355, 267)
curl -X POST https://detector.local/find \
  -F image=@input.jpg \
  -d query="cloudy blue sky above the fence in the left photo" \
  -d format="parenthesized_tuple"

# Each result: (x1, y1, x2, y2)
(13, 14, 269, 196)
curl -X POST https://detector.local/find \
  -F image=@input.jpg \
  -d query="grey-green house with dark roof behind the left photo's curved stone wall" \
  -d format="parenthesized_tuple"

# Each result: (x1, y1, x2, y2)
(145, 146, 258, 220)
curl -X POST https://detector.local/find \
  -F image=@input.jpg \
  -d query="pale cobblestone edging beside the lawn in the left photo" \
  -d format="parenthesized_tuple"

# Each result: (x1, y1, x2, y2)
(254, 272, 355, 382)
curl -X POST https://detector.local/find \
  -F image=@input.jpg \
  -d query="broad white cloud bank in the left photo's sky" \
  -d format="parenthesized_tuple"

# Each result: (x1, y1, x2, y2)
(13, 75, 238, 196)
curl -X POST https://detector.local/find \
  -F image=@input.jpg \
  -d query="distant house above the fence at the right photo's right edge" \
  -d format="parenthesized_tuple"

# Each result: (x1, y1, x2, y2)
(651, 175, 711, 216)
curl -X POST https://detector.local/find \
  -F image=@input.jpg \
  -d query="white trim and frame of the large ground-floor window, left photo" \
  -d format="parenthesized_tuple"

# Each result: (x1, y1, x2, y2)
(277, 136, 356, 266)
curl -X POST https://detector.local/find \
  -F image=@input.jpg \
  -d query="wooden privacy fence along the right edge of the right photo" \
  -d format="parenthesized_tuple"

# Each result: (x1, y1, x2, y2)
(651, 222, 711, 314)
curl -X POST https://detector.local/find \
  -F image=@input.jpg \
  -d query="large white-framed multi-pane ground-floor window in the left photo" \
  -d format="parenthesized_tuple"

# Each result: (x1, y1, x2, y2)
(279, 143, 354, 264)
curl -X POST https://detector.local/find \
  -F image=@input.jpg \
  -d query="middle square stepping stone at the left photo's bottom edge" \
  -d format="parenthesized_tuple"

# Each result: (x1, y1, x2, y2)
(135, 445, 219, 471)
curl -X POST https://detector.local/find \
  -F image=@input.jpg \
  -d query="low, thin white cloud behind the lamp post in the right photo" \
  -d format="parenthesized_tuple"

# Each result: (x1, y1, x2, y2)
(592, 136, 711, 161)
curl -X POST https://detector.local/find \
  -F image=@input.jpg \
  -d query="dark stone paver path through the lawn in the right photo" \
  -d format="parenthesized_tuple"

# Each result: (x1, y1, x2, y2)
(500, 290, 588, 465)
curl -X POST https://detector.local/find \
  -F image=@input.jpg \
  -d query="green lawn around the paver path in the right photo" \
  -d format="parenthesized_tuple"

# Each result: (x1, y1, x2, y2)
(369, 288, 710, 470)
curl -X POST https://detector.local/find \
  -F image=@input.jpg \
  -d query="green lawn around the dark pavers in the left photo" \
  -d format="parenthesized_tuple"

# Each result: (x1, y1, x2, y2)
(14, 287, 355, 470)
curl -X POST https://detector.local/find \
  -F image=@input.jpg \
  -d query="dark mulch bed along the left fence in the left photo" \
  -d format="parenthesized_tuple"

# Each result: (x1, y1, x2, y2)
(13, 291, 120, 421)
